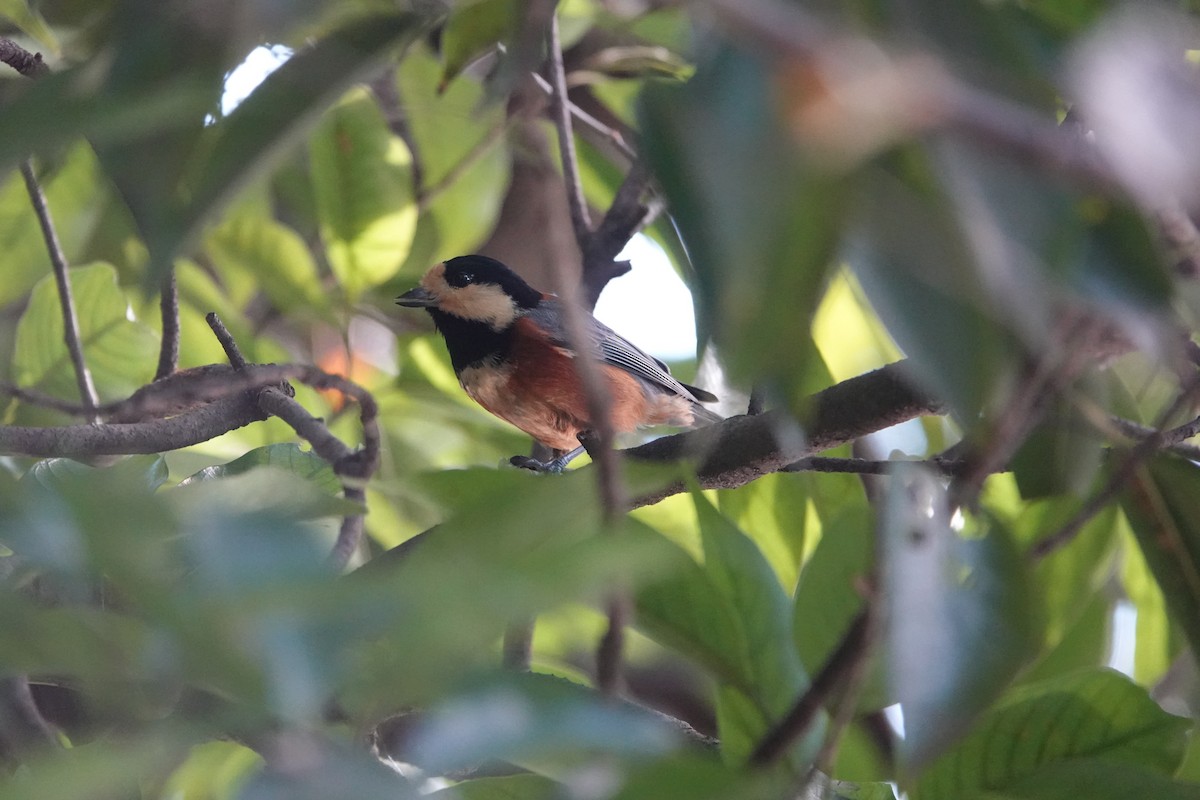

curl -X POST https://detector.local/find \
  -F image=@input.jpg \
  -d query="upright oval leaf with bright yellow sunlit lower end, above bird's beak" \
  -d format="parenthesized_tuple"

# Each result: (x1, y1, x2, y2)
(308, 89, 416, 297)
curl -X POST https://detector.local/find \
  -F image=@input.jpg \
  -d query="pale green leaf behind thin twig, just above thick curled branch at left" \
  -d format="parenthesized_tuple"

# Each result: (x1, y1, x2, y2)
(13, 264, 158, 401)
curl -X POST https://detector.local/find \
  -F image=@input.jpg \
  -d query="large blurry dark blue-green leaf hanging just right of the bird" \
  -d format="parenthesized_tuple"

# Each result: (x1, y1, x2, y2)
(641, 43, 848, 396)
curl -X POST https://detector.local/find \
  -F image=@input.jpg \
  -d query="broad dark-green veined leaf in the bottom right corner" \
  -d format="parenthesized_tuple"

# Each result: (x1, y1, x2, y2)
(913, 669, 1194, 800)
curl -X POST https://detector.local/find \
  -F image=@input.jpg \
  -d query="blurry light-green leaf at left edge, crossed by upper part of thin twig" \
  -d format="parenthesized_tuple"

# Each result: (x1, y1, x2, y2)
(0, 144, 108, 305)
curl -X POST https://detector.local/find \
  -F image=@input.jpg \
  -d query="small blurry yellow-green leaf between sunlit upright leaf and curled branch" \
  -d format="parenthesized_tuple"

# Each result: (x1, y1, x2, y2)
(205, 215, 330, 315)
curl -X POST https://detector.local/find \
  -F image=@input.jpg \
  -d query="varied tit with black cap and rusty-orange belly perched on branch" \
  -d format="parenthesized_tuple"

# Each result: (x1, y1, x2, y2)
(396, 255, 721, 471)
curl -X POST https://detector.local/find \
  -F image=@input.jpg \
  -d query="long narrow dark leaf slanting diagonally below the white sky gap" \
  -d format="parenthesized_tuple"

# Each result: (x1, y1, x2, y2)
(178, 12, 424, 262)
